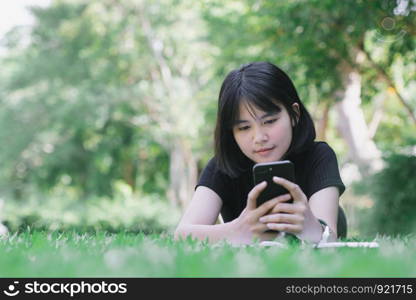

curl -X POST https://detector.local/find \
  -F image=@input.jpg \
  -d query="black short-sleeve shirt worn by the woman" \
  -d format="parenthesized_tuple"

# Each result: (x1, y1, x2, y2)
(196, 142, 345, 222)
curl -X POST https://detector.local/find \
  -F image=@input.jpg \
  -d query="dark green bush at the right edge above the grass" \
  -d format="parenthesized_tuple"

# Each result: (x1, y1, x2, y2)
(359, 154, 416, 235)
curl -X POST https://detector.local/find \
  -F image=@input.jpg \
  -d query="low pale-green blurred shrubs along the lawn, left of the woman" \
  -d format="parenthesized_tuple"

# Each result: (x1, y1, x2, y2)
(1, 180, 180, 234)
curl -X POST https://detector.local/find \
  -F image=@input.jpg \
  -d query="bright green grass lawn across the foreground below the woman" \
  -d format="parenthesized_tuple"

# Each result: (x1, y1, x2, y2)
(0, 231, 416, 277)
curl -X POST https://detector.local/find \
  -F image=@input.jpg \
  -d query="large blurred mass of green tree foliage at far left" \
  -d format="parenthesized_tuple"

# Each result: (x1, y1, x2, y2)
(0, 2, 160, 199)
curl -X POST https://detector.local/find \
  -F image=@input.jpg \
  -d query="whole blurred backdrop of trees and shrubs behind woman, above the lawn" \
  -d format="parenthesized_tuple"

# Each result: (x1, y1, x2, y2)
(0, 0, 416, 238)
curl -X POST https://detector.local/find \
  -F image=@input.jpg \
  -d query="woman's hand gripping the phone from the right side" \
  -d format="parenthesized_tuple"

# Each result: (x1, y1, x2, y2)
(259, 177, 322, 242)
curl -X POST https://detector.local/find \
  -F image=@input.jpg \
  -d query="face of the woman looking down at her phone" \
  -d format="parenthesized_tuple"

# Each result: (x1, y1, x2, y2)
(233, 101, 299, 163)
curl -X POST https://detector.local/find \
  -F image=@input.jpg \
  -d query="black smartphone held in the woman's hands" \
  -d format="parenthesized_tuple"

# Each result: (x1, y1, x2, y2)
(253, 160, 295, 207)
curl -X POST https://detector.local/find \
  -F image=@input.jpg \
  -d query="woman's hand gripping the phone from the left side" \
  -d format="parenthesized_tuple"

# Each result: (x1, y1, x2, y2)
(229, 181, 291, 244)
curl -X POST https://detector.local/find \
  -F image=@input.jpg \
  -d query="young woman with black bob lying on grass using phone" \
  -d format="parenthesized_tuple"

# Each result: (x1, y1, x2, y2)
(175, 62, 346, 244)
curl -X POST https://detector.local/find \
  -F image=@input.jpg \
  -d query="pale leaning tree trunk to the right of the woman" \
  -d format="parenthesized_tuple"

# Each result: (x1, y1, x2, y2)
(336, 59, 383, 176)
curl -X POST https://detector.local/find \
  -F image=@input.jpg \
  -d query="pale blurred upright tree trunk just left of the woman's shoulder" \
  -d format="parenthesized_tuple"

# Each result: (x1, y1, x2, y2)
(167, 139, 198, 209)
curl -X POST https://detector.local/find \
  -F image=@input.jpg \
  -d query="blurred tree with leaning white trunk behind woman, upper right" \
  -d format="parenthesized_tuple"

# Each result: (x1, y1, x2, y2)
(204, 0, 416, 175)
